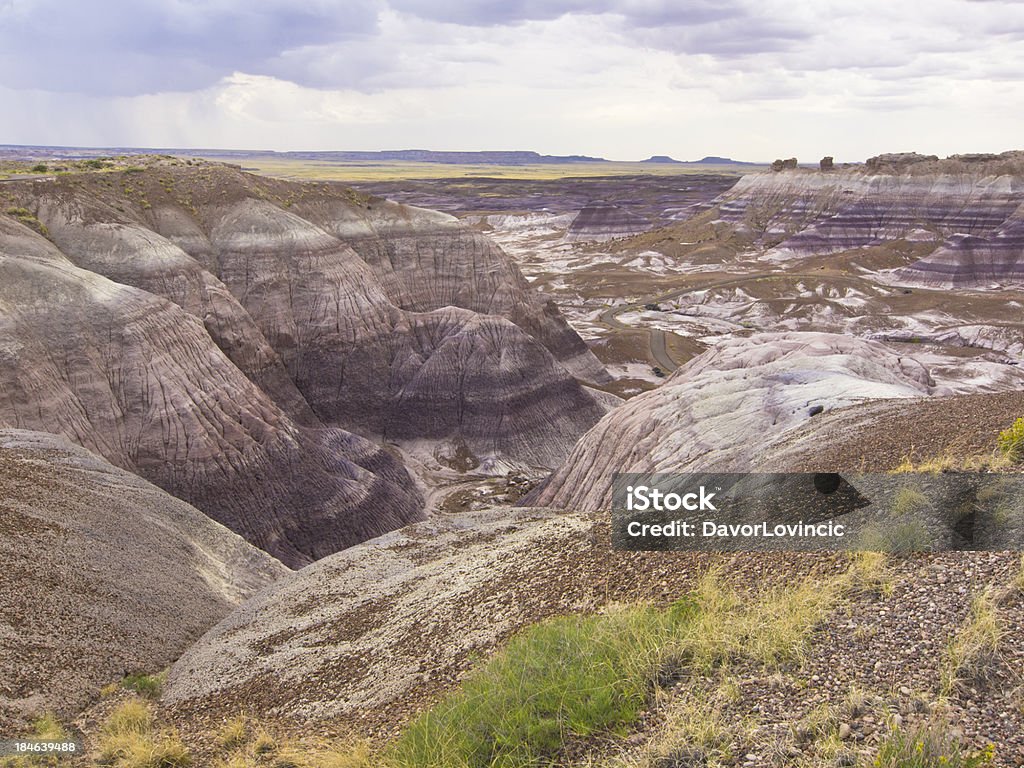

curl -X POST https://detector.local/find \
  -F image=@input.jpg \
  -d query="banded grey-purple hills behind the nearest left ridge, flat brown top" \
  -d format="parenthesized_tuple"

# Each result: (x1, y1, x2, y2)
(8, 166, 608, 466)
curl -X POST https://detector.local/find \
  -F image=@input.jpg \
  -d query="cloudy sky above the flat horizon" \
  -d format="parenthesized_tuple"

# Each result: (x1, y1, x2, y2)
(0, 0, 1024, 161)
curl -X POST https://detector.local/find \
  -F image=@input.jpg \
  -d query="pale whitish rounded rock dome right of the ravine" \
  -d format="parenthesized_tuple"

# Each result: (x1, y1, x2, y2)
(524, 333, 932, 510)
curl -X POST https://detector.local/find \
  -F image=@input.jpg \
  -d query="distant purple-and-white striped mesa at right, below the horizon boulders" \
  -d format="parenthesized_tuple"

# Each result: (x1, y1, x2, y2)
(716, 153, 1024, 288)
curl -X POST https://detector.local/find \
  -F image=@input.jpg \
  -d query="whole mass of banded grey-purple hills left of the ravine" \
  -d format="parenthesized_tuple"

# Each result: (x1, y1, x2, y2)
(0, 165, 607, 565)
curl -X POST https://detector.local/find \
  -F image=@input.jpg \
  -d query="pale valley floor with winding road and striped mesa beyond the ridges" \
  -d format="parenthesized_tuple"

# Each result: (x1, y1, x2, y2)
(355, 157, 1024, 396)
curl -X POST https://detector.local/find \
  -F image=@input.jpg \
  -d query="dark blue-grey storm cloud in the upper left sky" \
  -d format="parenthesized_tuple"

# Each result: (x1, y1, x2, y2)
(0, 0, 379, 95)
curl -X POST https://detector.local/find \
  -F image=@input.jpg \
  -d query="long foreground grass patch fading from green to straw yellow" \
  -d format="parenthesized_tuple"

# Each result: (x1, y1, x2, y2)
(386, 556, 860, 768)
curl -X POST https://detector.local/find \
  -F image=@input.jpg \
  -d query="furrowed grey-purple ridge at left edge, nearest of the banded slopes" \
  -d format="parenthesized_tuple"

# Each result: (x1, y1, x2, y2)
(0, 219, 422, 565)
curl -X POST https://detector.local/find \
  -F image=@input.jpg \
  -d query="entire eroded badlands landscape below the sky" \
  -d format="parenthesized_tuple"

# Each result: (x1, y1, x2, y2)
(0, 153, 1024, 768)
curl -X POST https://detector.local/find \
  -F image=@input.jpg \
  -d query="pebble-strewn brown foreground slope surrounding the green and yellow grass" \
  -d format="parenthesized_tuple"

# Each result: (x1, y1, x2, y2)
(164, 508, 1024, 766)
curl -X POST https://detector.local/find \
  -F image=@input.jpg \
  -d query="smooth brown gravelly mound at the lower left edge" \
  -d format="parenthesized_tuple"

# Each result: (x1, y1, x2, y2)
(0, 430, 289, 734)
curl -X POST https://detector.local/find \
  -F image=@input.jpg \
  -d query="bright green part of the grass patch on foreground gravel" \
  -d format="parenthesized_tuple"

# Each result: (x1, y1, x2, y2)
(391, 602, 693, 768)
